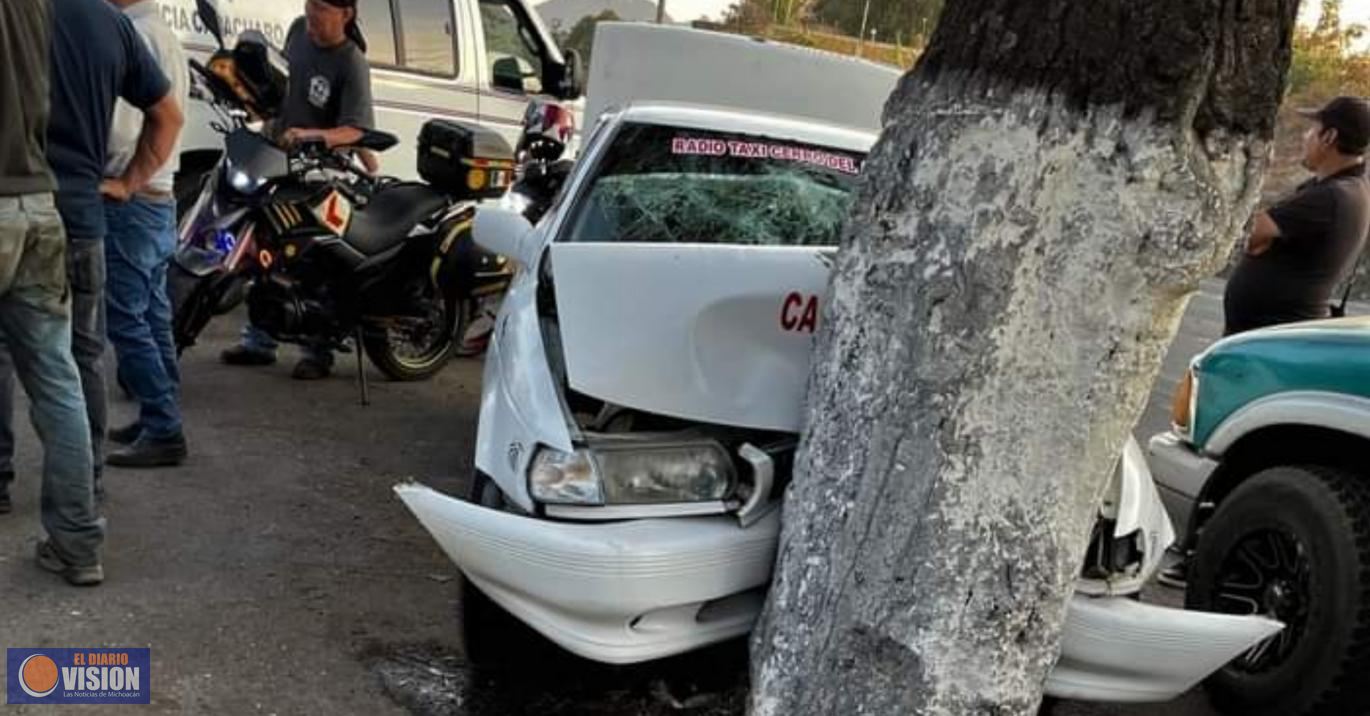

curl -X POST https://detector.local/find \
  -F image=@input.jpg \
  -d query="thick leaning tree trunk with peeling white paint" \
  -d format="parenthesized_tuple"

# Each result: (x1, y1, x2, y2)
(751, 0, 1297, 716)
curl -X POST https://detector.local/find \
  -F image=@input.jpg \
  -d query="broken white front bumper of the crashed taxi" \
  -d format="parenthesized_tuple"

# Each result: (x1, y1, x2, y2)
(395, 485, 1280, 701)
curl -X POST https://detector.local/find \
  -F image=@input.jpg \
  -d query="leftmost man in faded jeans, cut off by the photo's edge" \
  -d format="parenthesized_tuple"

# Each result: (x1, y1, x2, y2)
(0, 0, 104, 586)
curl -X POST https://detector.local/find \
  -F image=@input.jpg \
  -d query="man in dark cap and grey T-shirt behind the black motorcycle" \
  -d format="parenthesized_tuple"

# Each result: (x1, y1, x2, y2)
(221, 0, 375, 381)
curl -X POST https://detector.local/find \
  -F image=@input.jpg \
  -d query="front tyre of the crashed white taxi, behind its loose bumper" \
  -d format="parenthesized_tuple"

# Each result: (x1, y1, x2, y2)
(458, 472, 556, 671)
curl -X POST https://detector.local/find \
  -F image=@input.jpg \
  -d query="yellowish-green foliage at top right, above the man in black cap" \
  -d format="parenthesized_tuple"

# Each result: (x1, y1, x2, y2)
(1289, 0, 1370, 99)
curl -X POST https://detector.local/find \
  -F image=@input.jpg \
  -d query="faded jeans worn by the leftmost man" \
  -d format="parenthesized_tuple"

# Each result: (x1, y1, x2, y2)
(0, 194, 104, 567)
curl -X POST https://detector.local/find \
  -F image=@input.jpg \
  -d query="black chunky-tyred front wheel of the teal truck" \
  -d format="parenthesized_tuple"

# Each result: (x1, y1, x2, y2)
(1185, 465, 1370, 716)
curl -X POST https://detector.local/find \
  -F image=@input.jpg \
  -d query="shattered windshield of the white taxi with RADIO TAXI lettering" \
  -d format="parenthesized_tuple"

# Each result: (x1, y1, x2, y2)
(569, 125, 864, 246)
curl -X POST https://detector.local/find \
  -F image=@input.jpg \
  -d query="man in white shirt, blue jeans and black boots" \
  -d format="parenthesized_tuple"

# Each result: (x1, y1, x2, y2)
(104, 0, 190, 467)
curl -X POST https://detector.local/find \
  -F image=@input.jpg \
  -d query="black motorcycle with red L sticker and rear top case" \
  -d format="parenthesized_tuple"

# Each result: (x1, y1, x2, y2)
(169, 3, 515, 381)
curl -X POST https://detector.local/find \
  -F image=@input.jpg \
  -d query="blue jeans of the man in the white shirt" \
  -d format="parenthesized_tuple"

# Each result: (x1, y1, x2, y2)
(104, 199, 181, 438)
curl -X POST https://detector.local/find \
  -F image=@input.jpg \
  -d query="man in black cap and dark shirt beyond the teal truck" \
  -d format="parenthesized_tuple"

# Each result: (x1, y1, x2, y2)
(1223, 97, 1370, 335)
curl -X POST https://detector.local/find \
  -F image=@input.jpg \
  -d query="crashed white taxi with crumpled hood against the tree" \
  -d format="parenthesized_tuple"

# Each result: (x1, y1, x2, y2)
(396, 96, 1280, 701)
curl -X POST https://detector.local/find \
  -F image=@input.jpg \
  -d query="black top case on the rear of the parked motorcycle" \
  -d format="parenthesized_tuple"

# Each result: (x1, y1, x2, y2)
(419, 119, 514, 200)
